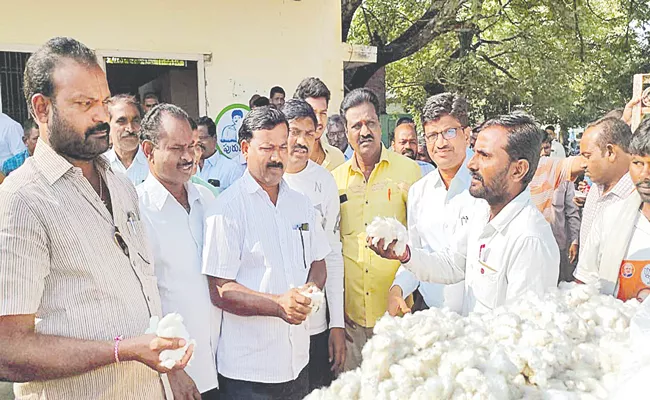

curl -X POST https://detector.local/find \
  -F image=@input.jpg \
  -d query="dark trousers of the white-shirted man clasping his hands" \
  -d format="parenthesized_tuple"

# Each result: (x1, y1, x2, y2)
(219, 367, 309, 400)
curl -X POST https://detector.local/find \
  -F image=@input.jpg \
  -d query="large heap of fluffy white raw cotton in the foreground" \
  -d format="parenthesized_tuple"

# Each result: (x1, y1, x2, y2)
(307, 284, 639, 400)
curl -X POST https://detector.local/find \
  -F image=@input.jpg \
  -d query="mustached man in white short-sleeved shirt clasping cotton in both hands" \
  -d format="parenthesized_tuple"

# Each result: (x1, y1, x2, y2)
(203, 106, 331, 400)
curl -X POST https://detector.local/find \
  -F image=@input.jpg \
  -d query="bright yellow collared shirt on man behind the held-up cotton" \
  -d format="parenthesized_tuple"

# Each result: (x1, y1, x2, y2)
(332, 146, 421, 328)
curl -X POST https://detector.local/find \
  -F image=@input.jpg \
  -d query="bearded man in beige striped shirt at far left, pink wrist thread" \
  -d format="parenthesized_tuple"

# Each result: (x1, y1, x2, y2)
(0, 37, 192, 400)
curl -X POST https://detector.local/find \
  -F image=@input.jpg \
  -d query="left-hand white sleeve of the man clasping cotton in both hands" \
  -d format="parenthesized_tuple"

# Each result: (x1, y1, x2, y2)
(202, 200, 244, 280)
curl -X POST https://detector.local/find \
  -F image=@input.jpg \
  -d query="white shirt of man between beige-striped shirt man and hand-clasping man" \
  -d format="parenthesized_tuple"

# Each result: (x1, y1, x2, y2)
(137, 175, 221, 393)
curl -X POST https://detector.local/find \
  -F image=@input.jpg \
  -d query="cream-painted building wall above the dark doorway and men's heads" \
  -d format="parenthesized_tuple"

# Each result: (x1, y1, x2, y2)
(0, 0, 343, 117)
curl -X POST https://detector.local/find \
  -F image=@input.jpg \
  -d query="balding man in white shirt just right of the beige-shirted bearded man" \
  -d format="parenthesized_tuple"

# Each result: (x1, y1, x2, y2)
(137, 104, 221, 400)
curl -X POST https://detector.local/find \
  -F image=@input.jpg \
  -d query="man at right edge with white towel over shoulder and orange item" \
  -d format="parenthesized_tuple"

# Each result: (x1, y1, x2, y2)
(574, 118, 650, 301)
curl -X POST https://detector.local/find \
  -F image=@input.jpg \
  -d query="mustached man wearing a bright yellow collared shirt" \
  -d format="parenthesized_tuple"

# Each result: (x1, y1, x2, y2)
(332, 88, 421, 370)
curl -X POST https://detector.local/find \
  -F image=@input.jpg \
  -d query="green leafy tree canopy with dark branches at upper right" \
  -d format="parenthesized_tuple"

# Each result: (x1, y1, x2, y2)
(342, 0, 650, 127)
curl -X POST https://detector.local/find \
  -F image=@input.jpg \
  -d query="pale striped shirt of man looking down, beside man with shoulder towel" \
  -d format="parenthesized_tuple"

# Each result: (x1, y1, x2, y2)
(579, 172, 636, 254)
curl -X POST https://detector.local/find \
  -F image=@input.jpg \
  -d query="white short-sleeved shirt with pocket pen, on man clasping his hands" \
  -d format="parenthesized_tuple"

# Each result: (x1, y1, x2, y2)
(203, 170, 330, 383)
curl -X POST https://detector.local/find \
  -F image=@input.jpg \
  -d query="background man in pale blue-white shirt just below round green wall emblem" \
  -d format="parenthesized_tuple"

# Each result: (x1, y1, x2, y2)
(196, 117, 244, 190)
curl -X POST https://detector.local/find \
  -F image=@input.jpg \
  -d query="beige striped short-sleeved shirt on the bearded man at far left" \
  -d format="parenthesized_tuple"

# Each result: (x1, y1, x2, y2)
(0, 141, 164, 400)
